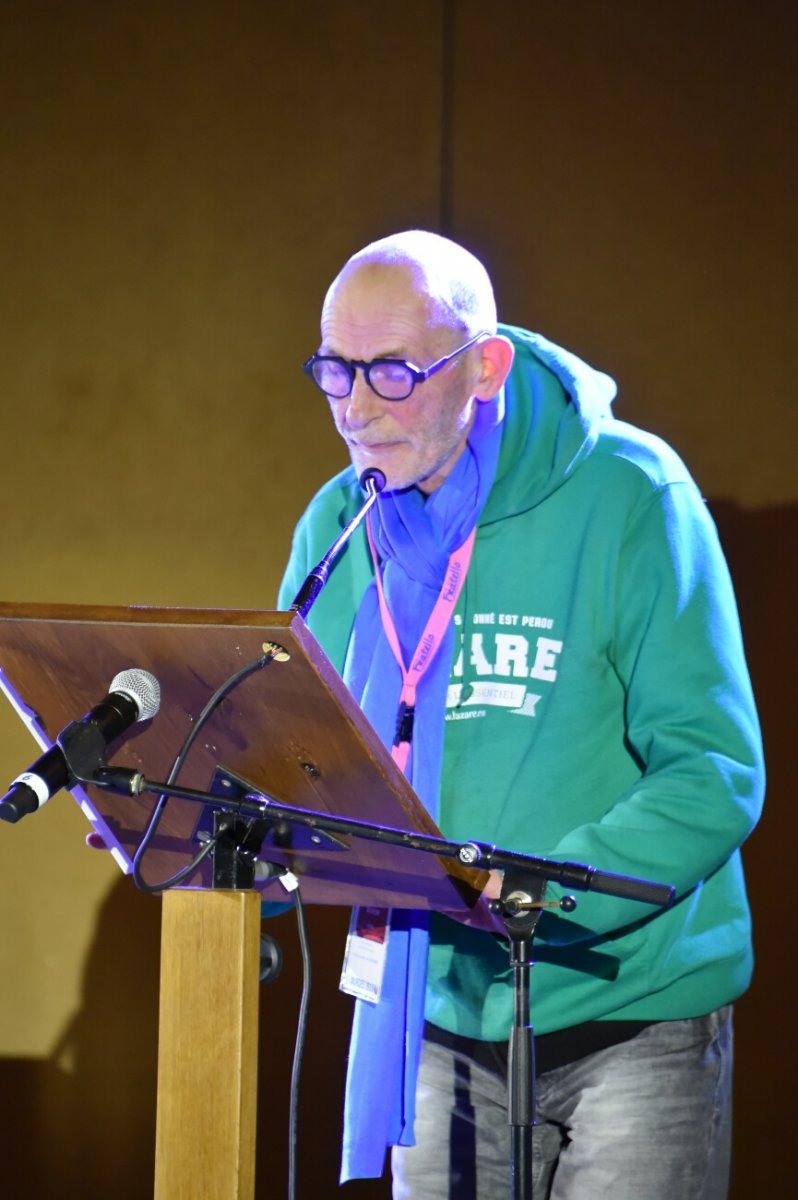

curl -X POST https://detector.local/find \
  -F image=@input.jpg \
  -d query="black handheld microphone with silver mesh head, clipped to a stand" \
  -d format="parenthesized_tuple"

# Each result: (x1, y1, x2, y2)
(0, 667, 161, 824)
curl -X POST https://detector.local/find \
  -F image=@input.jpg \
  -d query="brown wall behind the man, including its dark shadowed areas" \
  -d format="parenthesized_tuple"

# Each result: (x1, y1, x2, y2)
(0, 0, 798, 1200)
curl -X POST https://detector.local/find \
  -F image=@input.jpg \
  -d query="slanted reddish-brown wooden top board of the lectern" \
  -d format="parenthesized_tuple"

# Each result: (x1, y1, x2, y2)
(0, 602, 484, 929)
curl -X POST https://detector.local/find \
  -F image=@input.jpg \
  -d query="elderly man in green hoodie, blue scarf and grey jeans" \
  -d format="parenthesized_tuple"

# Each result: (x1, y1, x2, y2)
(281, 232, 762, 1200)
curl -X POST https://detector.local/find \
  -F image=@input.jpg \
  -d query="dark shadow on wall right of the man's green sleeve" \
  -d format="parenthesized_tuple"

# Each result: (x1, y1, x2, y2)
(709, 502, 798, 1200)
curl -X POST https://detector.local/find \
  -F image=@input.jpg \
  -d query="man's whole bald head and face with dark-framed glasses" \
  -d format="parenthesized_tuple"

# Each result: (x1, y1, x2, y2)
(319, 230, 512, 493)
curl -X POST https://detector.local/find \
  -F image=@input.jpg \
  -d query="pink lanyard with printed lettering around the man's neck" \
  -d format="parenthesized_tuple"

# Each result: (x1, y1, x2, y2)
(367, 521, 476, 770)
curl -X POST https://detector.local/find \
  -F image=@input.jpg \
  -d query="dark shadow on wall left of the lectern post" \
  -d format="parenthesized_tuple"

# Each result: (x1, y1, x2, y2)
(0, 878, 161, 1200)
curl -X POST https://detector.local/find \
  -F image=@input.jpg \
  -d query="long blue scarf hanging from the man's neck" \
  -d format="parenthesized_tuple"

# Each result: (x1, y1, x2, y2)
(341, 396, 504, 1183)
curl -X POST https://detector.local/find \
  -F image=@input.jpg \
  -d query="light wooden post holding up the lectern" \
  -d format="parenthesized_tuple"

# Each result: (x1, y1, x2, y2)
(155, 892, 260, 1200)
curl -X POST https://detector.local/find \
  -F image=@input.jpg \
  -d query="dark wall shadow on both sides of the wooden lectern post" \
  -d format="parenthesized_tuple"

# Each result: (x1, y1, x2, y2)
(0, 878, 390, 1200)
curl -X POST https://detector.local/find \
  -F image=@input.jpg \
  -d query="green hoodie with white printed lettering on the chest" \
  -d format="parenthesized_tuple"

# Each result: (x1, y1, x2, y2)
(281, 328, 762, 1040)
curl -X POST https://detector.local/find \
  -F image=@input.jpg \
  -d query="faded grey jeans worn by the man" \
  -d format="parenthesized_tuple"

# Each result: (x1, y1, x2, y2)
(392, 1006, 732, 1200)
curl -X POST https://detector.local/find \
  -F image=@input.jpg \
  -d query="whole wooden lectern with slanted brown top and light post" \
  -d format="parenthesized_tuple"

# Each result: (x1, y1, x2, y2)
(0, 604, 494, 1200)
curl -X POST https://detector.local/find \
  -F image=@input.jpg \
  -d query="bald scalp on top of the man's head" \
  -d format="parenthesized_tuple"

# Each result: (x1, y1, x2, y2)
(324, 229, 497, 337)
